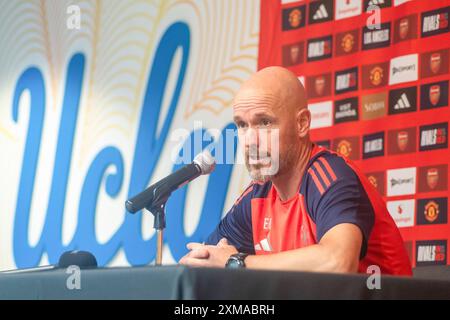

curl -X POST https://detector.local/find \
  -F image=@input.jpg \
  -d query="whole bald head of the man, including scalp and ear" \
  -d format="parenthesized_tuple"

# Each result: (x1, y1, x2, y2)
(233, 67, 311, 181)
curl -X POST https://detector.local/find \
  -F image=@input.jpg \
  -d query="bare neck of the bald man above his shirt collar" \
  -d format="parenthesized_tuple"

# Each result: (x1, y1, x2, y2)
(272, 142, 313, 201)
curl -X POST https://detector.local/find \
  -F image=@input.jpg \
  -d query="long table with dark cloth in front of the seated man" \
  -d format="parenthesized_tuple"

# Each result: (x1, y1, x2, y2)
(0, 266, 450, 300)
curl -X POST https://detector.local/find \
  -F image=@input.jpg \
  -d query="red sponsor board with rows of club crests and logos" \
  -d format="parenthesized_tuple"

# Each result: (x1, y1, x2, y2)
(258, 0, 450, 266)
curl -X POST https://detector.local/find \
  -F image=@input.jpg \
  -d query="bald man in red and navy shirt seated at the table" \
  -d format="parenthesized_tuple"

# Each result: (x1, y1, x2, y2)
(180, 67, 412, 275)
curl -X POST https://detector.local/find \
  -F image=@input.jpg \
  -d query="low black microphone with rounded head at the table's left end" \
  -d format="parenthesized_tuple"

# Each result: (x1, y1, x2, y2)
(1, 250, 97, 274)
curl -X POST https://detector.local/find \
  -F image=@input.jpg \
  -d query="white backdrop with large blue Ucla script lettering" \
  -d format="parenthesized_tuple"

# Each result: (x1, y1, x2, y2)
(0, 0, 260, 270)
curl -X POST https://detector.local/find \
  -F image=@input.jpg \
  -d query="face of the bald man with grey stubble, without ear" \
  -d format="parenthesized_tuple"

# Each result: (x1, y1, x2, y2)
(233, 91, 296, 182)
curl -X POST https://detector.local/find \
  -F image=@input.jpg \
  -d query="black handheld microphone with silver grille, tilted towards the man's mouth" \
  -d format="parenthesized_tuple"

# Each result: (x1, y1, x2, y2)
(125, 150, 216, 213)
